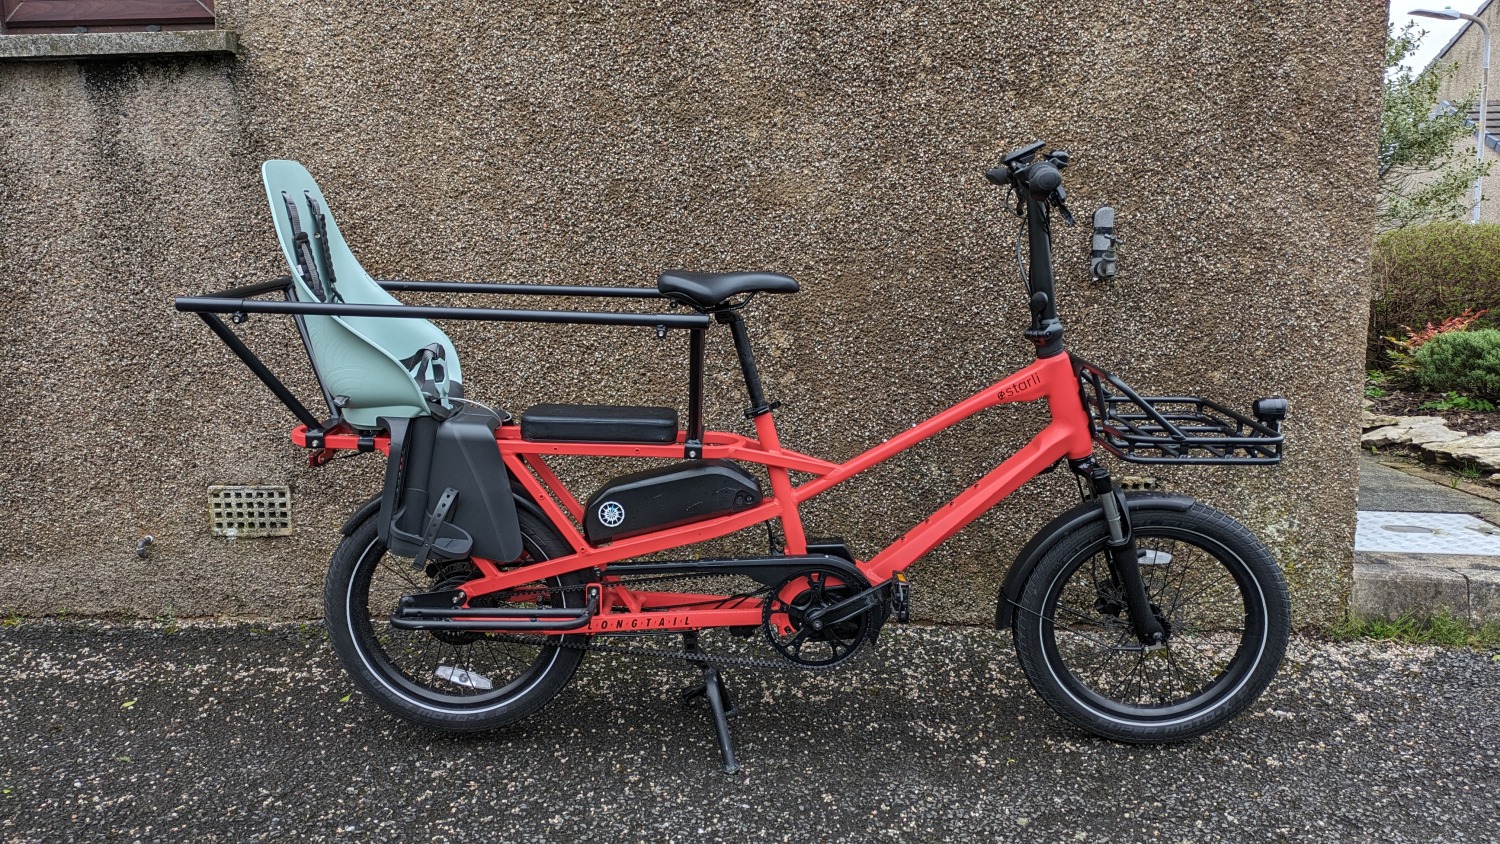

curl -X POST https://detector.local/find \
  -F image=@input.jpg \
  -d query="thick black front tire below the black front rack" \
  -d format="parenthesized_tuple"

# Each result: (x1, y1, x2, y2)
(1013, 504, 1292, 744)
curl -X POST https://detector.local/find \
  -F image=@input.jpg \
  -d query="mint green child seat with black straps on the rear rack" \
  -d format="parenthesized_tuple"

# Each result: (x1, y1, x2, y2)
(261, 160, 464, 430)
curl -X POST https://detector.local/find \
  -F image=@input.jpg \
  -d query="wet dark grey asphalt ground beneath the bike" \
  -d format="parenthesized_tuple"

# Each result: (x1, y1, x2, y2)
(0, 621, 1500, 843)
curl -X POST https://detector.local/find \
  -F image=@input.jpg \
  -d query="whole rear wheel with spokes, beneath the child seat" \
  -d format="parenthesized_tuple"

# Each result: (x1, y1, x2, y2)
(324, 511, 587, 732)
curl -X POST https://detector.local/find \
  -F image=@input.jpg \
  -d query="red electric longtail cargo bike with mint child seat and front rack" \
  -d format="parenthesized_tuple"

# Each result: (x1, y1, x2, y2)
(176, 142, 1290, 771)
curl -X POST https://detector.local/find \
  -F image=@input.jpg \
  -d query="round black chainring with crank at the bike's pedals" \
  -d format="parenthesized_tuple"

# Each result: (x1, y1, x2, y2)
(761, 567, 884, 669)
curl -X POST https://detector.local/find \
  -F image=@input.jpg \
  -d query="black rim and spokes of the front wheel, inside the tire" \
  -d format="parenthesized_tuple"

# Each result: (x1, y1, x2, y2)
(1038, 526, 1266, 721)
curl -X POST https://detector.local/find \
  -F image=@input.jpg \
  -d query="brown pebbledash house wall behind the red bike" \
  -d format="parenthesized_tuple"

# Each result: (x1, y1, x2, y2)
(0, 0, 1385, 625)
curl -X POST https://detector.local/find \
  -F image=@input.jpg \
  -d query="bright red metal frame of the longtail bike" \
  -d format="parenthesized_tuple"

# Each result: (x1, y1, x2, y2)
(293, 352, 1094, 634)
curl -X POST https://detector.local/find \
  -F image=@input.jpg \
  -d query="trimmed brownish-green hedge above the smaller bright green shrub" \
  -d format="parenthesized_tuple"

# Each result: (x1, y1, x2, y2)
(1367, 222, 1500, 369)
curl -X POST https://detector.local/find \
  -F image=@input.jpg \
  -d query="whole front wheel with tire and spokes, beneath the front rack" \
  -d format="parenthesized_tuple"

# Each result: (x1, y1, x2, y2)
(1013, 504, 1292, 744)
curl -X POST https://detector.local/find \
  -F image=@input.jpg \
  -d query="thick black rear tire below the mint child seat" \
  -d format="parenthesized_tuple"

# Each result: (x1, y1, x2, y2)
(324, 508, 587, 733)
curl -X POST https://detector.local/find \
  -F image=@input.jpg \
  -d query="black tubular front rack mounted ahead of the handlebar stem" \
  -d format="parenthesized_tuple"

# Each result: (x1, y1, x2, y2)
(1074, 358, 1286, 466)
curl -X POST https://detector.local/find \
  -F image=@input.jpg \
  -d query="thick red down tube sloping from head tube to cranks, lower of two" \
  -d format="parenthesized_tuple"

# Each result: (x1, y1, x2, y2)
(860, 423, 1070, 583)
